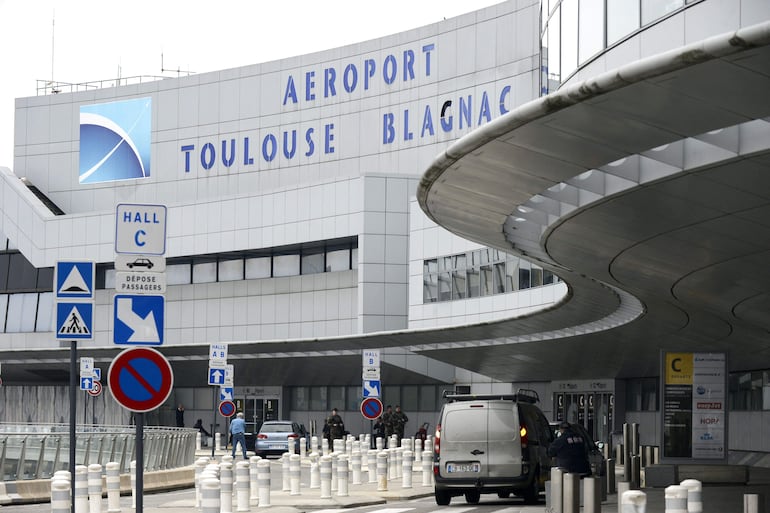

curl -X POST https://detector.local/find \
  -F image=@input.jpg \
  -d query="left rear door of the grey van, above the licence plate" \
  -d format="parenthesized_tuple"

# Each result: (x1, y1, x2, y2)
(439, 401, 489, 479)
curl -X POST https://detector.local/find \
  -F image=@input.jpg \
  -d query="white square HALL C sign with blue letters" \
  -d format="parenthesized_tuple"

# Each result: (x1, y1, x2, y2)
(115, 203, 166, 255)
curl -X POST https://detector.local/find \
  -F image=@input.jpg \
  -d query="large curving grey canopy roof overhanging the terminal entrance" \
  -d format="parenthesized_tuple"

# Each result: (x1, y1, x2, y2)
(418, 22, 770, 381)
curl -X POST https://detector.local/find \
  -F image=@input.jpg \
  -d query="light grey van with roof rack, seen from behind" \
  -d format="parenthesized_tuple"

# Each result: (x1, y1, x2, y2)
(433, 389, 553, 506)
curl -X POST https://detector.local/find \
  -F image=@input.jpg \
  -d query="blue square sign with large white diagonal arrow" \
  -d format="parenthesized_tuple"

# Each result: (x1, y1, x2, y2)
(113, 294, 165, 346)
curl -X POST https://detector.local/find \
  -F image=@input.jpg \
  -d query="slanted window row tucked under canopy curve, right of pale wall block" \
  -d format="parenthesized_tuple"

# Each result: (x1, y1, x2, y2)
(422, 248, 559, 303)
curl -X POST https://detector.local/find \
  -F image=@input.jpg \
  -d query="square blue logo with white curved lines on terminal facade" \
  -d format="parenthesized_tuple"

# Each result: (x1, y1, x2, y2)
(79, 98, 152, 184)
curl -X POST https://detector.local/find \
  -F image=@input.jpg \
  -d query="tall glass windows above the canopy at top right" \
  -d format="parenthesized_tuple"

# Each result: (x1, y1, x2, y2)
(540, 0, 703, 94)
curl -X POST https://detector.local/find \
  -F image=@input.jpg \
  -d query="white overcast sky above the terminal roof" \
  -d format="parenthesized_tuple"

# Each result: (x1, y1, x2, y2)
(0, 0, 502, 169)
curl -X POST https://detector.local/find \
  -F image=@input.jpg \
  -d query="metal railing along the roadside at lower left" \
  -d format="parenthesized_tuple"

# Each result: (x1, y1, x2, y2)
(0, 423, 198, 481)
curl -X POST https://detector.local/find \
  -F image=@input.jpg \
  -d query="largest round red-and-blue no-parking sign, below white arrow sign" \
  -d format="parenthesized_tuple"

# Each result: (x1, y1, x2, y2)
(107, 347, 174, 413)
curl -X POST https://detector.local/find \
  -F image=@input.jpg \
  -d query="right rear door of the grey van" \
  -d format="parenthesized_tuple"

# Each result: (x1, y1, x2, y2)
(487, 401, 521, 478)
